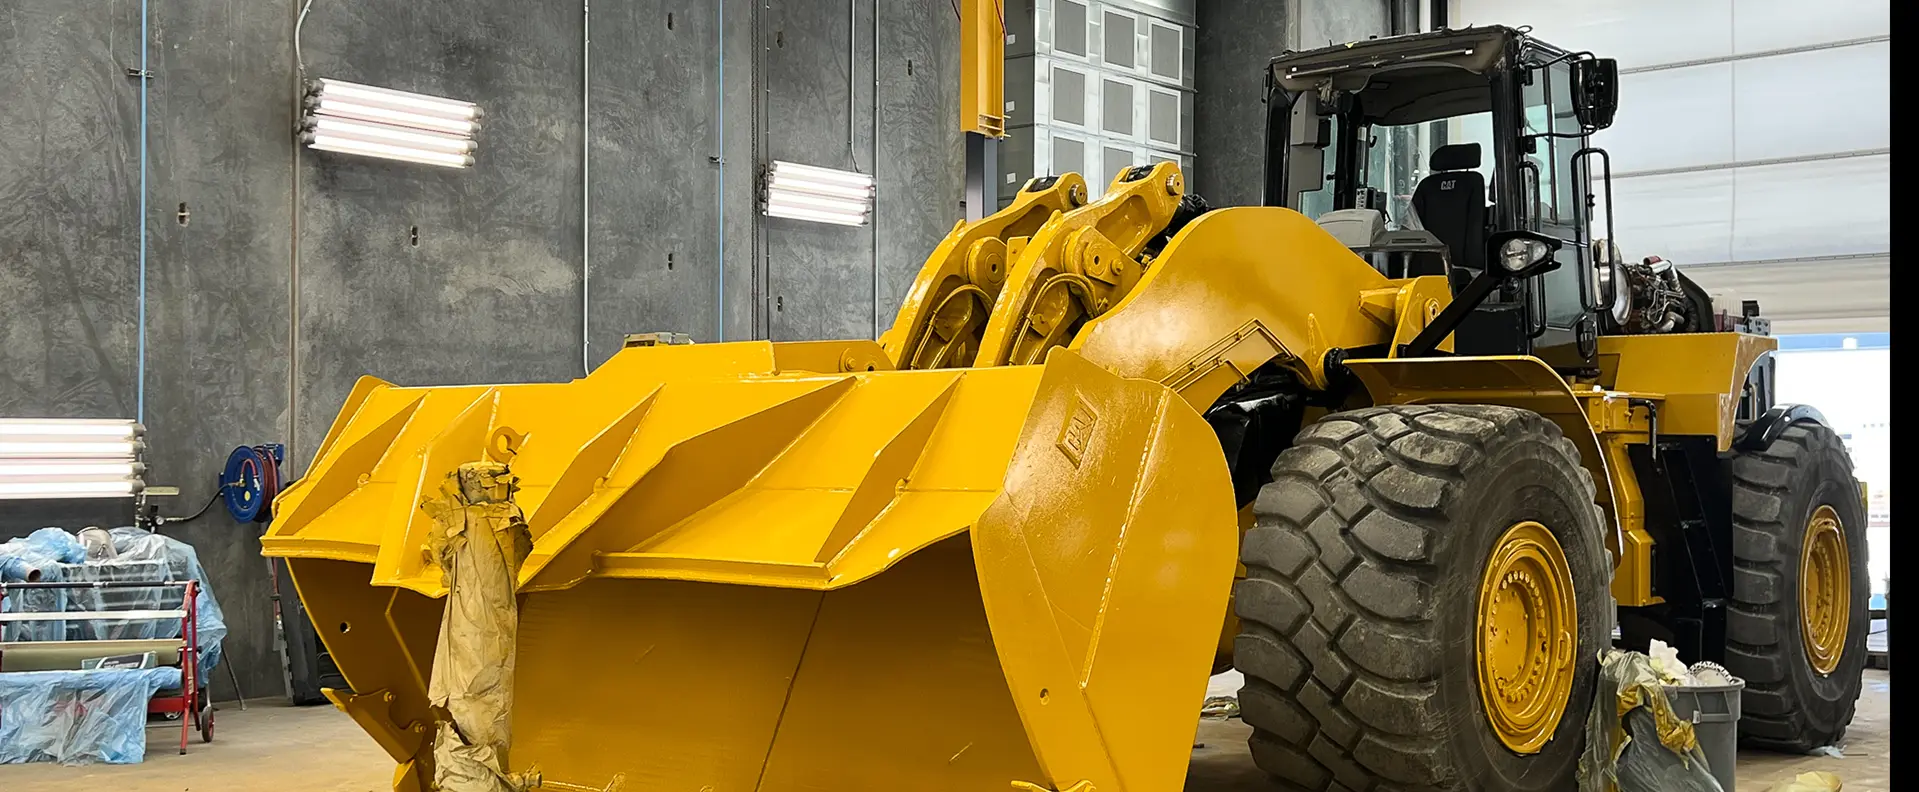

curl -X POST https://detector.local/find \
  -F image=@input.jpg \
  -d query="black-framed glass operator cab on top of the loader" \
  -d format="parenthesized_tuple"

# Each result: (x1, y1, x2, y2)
(1265, 27, 1618, 374)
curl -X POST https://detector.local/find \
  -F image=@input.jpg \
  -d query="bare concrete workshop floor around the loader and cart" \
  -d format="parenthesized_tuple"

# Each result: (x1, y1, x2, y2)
(0, 671, 1892, 792)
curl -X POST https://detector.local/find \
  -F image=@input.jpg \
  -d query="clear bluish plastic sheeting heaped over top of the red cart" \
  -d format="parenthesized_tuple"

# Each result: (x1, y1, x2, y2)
(0, 525, 226, 679)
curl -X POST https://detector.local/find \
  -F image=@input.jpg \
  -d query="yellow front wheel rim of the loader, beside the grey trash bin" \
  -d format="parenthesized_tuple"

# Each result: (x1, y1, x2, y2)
(1476, 522, 1579, 754)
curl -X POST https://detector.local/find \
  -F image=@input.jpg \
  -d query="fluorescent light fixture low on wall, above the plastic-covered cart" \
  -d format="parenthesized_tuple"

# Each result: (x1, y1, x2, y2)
(0, 418, 146, 501)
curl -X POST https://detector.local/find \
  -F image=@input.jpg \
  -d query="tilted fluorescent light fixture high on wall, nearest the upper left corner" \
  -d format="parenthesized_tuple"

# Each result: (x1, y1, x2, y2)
(299, 79, 484, 167)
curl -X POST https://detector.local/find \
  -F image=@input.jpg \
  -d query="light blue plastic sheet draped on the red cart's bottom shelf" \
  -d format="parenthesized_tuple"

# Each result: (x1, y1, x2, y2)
(0, 667, 180, 765)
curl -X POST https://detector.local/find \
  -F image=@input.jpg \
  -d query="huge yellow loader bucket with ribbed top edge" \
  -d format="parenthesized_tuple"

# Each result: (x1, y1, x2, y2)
(263, 341, 1238, 792)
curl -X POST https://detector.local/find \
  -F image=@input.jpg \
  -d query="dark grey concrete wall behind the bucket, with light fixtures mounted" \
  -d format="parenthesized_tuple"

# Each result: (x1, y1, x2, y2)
(0, 0, 963, 696)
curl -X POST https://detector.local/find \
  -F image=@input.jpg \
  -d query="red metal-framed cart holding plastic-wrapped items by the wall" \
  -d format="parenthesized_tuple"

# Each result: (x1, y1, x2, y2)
(0, 581, 213, 754)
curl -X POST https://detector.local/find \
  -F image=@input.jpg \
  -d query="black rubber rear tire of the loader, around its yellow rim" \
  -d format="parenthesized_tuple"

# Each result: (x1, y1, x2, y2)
(1725, 422, 1871, 754)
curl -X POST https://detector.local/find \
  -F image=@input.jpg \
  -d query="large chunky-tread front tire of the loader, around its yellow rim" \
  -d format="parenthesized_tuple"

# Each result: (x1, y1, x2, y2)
(1234, 405, 1614, 790)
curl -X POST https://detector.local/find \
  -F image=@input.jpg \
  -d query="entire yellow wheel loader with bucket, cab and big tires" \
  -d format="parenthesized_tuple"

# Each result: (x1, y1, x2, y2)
(263, 27, 1867, 792)
